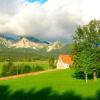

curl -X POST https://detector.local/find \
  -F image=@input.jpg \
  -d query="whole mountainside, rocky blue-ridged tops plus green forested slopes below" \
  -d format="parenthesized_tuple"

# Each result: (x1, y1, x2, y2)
(0, 35, 72, 61)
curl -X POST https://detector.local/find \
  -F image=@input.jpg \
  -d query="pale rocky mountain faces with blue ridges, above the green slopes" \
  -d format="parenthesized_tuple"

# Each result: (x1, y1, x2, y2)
(0, 34, 63, 52)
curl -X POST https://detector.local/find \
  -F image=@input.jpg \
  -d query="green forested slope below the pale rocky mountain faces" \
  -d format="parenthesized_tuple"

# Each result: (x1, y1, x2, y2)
(0, 44, 71, 61)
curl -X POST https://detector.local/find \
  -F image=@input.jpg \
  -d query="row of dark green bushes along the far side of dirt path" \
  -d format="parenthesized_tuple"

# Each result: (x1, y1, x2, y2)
(0, 60, 44, 76)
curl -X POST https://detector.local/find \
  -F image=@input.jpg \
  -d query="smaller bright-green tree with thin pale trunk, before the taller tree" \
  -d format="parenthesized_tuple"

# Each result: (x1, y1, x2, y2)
(74, 50, 92, 83)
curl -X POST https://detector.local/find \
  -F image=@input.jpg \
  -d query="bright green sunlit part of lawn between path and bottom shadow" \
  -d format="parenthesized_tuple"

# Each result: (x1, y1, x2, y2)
(0, 69, 100, 97)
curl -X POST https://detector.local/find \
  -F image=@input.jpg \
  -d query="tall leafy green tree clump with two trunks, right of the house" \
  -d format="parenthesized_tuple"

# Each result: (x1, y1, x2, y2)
(73, 20, 100, 82)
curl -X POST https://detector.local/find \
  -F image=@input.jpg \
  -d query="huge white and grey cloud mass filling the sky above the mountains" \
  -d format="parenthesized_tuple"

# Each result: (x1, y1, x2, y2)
(0, 0, 100, 40)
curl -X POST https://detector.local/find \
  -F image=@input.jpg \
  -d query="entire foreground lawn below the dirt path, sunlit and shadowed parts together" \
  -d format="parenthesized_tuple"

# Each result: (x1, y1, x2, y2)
(0, 69, 100, 100)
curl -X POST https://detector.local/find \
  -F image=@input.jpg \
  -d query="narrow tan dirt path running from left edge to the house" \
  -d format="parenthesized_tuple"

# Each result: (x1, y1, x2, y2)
(0, 69, 57, 80)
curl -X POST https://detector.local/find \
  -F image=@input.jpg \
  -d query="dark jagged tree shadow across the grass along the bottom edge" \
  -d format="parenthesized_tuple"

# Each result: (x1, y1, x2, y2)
(0, 86, 100, 100)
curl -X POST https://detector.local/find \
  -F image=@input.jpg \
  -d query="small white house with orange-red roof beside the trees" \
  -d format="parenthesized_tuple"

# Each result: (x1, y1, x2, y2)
(57, 55, 73, 69)
